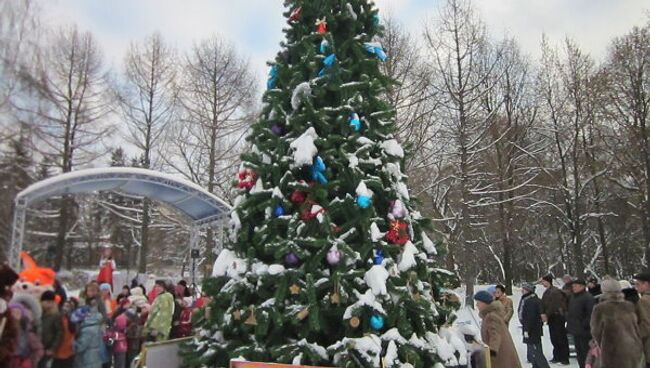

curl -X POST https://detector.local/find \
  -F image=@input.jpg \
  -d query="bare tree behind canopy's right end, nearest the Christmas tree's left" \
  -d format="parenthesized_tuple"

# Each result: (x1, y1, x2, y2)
(165, 36, 256, 268)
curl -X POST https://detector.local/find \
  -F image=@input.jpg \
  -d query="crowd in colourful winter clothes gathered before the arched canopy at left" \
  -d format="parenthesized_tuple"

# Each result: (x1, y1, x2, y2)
(0, 265, 207, 368)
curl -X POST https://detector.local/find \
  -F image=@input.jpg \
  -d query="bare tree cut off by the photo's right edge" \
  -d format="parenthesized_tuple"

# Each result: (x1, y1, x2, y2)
(605, 25, 650, 269)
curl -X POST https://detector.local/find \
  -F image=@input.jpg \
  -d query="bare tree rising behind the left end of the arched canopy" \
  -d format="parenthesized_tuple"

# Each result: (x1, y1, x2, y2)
(17, 27, 112, 270)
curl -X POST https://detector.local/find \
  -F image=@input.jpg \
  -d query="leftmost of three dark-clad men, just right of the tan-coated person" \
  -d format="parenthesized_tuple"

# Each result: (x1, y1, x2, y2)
(517, 283, 548, 368)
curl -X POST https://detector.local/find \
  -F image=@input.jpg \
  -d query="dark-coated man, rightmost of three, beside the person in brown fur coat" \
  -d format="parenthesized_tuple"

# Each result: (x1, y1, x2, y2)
(567, 279, 595, 368)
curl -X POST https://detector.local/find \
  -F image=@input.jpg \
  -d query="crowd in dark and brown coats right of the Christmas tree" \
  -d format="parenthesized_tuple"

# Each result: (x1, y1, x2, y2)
(466, 272, 650, 368)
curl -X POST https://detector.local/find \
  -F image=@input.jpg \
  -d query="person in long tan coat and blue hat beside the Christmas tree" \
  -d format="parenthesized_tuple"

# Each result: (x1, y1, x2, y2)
(474, 290, 521, 368)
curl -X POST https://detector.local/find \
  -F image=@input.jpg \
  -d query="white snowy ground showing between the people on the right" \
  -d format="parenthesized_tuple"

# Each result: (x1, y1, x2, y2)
(450, 285, 578, 368)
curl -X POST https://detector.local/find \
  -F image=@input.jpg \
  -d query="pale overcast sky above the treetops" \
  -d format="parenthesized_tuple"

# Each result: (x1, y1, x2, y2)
(41, 0, 650, 86)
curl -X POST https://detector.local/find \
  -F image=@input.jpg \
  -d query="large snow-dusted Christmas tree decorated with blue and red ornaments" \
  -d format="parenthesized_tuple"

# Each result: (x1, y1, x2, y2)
(184, 0, 464, 368)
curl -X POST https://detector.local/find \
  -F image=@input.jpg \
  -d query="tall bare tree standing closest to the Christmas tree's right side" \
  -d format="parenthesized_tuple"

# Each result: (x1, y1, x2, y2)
(472, 39, 546, 292)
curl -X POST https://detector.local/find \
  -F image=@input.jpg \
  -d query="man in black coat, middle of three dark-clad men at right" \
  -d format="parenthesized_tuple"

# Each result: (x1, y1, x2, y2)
(541, 274, 569, 365)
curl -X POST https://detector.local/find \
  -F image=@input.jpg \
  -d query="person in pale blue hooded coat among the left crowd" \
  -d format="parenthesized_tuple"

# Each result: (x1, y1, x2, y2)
(72, 303, 104, 368)
